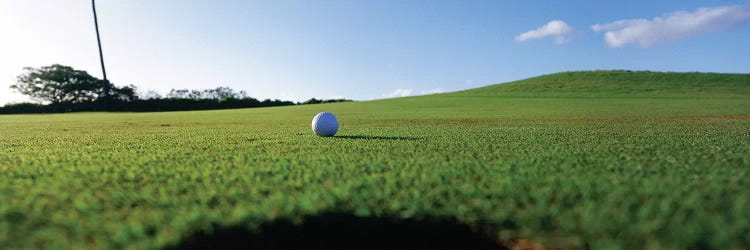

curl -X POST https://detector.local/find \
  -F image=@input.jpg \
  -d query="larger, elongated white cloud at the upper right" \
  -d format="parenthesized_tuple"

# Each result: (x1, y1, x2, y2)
(591, 6, 750, 48)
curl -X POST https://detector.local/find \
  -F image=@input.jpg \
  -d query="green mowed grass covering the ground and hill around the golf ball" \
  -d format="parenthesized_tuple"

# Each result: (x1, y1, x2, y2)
(0, 71, 750, 249)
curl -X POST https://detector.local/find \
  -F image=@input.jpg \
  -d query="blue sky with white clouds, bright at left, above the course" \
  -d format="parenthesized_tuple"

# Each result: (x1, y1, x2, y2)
(0, 0, 750, 105)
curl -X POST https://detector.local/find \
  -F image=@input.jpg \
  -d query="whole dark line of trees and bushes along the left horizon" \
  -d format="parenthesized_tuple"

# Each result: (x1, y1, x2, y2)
(0, 64, 351, 114)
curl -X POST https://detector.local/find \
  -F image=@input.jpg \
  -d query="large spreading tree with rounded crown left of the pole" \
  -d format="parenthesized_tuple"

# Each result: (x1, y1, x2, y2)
(10, 64, 103, 103)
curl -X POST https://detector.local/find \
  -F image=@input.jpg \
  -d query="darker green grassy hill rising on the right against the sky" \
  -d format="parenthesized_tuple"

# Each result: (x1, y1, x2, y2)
(456, 70, 750, 97)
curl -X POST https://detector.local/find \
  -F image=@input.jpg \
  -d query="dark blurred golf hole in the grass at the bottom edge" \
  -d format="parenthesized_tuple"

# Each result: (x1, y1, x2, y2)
(172, 213, 506, 249)
